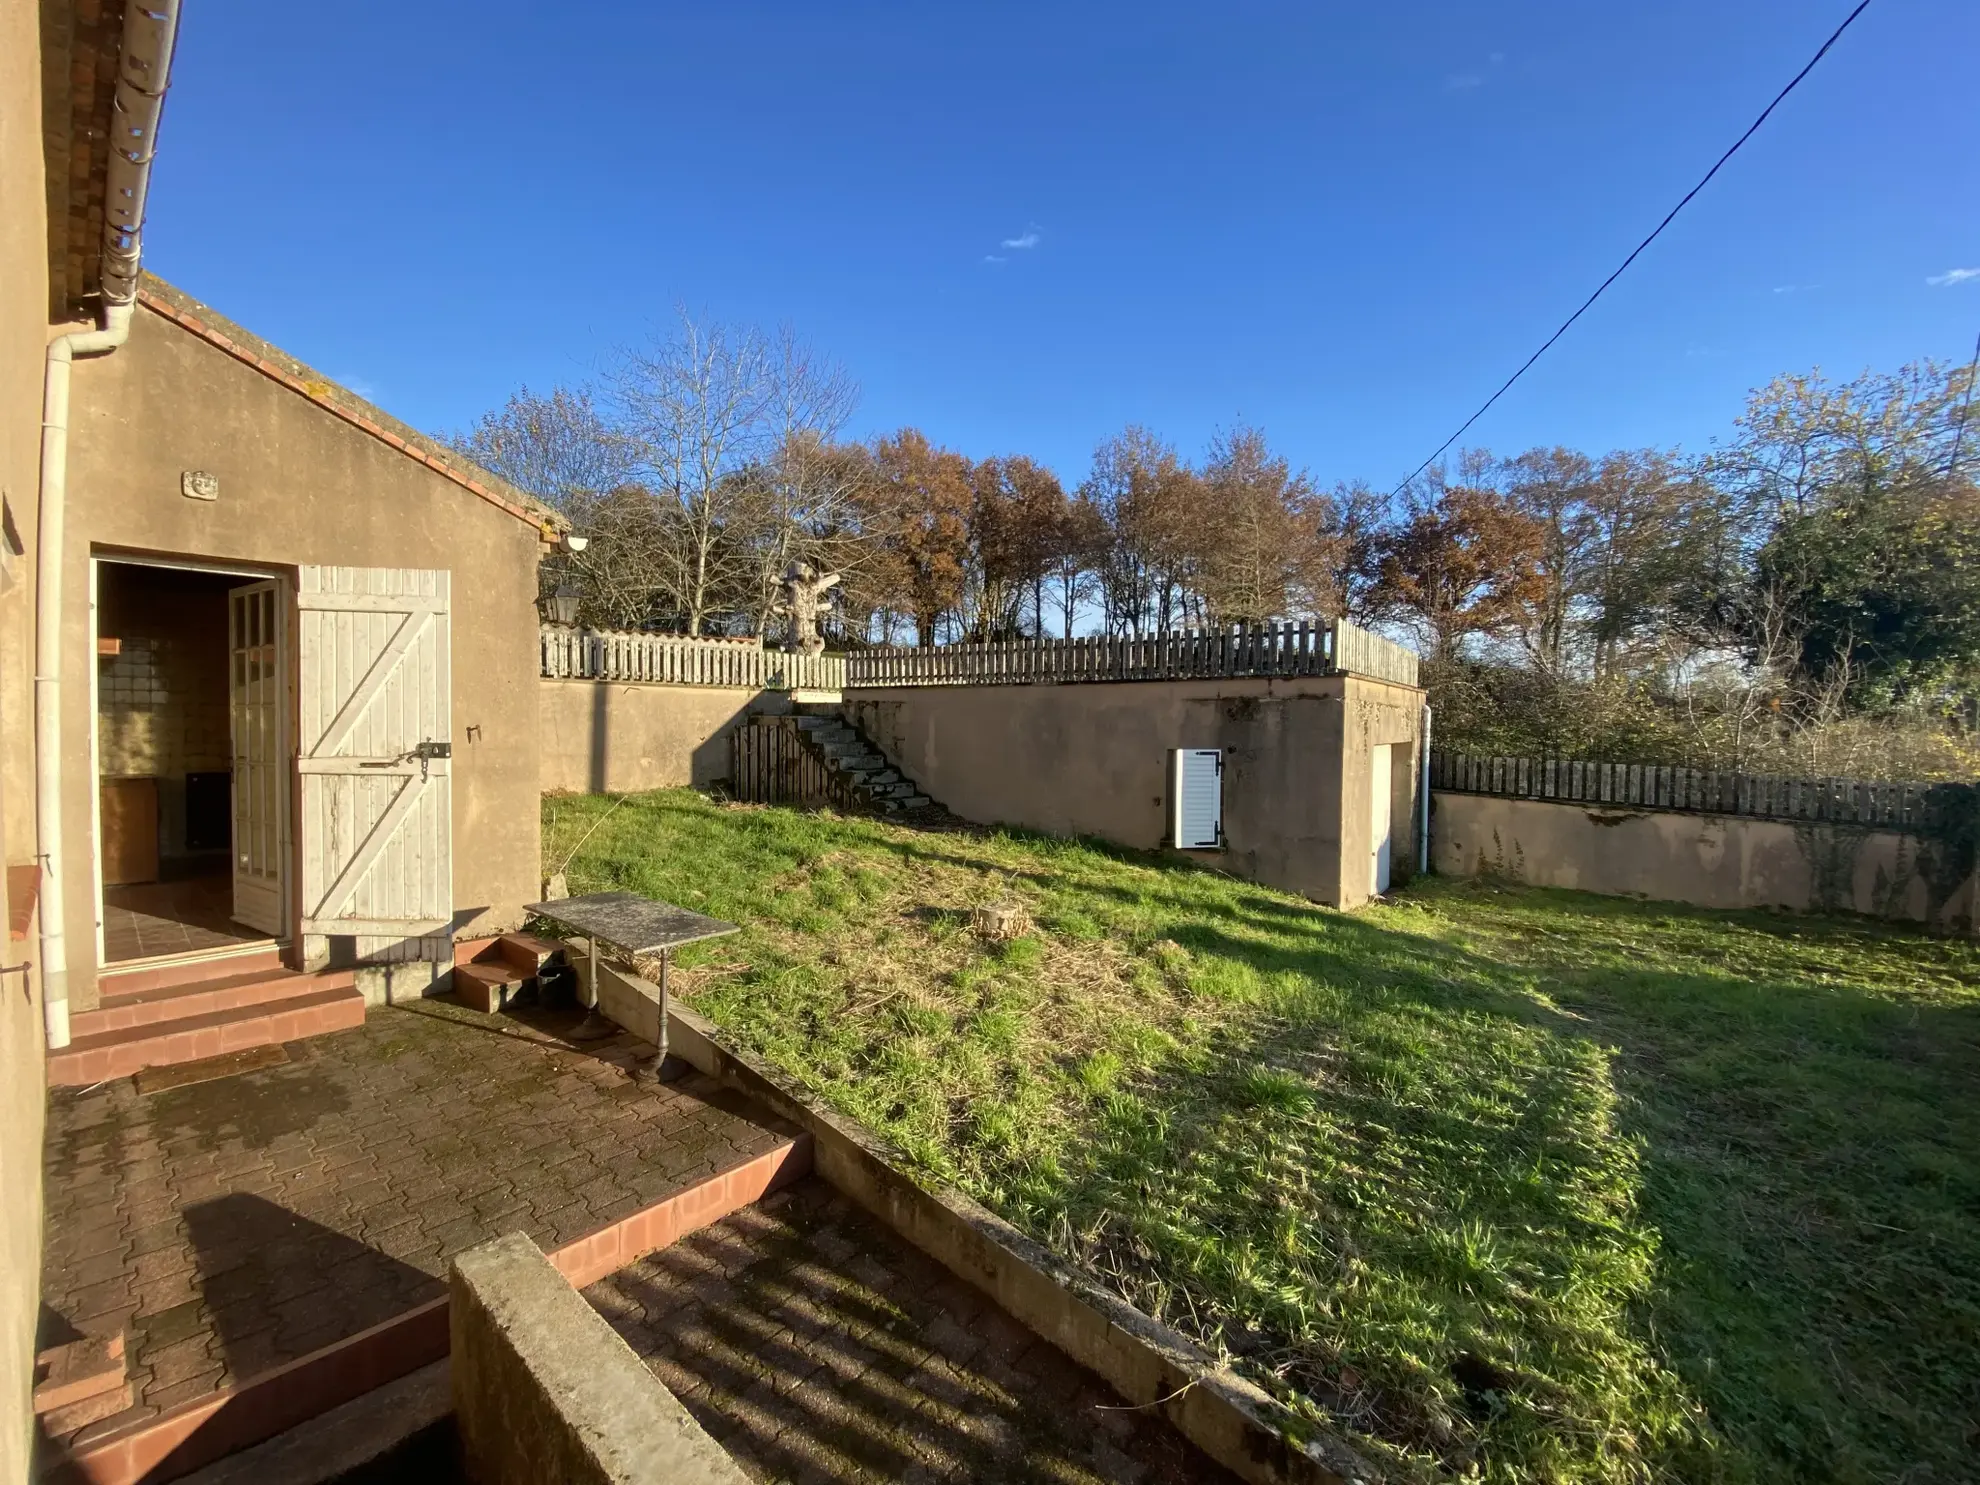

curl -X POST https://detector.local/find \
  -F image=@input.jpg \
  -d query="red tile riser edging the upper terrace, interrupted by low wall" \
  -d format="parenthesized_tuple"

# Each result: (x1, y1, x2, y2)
(44, 1135, 812, 1485)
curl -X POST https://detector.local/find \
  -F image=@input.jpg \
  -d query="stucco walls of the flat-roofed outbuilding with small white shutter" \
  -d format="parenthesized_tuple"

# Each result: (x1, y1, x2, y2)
(845, 675, 1422, 907)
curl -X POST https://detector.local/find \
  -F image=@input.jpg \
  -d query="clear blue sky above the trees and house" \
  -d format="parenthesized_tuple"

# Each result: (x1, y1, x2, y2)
(147, 0, 1980, 496)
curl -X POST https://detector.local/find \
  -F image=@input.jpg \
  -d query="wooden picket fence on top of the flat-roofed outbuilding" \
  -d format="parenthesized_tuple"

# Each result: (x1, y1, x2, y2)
(845, 620, 1418, 687)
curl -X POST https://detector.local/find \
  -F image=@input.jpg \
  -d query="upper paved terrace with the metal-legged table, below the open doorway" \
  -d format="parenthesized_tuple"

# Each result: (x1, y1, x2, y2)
(42, 1000, 792, 1449)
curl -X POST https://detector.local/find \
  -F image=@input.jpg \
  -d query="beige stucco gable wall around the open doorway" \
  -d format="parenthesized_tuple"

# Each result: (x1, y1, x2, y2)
(63, 279, 543, 1010)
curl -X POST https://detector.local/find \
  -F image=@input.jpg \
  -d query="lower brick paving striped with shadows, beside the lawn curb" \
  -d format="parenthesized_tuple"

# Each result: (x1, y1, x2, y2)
(584, 1180, 1234, 1485)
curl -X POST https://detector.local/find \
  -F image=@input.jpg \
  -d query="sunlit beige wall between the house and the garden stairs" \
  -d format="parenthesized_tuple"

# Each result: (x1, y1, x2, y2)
(537, 679, 790, 794)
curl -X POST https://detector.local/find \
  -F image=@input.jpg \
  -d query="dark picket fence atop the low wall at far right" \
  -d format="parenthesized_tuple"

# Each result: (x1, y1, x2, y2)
(1430, 750, 1946, 830)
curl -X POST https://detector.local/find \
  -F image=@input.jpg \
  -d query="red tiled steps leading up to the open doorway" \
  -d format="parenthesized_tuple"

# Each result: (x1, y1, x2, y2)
(48, 948, 364, 1087)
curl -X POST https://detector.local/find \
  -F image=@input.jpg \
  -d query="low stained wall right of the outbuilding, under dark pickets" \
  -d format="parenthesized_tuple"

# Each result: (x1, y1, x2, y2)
(1430, 790, 1976, 927)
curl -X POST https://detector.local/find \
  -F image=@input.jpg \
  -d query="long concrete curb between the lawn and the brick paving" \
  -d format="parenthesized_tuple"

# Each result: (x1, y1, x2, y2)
(665, 1001, 1380, 1485)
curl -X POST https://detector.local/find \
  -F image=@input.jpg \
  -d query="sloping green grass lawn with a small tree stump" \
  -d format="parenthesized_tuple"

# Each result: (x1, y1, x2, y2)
(545, 790, 1980, 1485)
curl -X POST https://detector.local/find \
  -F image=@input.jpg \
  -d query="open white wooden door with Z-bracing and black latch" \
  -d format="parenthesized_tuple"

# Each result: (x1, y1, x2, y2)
(295, 566, 453, 964)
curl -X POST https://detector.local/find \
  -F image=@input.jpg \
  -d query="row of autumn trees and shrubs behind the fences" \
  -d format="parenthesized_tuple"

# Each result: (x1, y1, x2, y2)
(453, 315, 1980, 776)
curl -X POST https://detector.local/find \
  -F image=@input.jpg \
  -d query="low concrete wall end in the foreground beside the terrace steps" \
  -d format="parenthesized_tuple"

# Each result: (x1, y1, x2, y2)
(447, 1232, 748, 1485)
